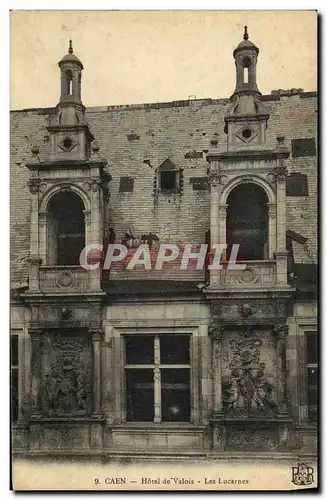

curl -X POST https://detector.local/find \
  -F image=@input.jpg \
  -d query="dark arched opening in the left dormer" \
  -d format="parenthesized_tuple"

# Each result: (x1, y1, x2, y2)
(47, 192, 85, 266)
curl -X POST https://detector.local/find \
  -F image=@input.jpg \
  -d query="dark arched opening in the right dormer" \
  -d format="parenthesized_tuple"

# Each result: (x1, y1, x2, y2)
(226, 183, 269, 260)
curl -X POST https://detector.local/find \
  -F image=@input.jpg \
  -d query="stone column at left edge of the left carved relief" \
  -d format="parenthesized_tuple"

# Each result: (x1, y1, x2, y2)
(29, 329, 42, 418)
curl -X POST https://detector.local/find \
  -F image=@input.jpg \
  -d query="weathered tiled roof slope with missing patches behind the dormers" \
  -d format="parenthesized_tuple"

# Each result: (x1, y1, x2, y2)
(10, 93, 317, 283)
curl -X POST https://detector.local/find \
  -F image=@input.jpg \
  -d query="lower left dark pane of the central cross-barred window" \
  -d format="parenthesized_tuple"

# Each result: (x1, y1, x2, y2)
(126, 370, 154, 422)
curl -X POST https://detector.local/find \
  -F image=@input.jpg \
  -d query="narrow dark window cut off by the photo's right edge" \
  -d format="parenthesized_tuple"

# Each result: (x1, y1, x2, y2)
(306, 332, 318, 422)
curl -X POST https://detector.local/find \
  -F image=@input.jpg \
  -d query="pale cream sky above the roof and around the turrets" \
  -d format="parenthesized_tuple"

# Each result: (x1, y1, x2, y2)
(10, 10, 317, 109)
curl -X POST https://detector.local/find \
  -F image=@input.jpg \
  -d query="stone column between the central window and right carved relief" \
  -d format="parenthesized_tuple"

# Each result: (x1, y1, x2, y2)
(209, 316, 224, 416)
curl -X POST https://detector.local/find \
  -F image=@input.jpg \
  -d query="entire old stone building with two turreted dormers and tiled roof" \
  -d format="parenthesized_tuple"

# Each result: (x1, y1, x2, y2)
(11, 30, 318, 457)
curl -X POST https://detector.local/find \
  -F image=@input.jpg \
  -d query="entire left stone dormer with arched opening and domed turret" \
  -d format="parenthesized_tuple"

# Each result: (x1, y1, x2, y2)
(26, 40, 111, 294)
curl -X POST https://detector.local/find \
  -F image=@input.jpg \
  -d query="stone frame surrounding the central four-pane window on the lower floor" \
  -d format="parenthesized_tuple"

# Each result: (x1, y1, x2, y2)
(116, 327, 200, 427)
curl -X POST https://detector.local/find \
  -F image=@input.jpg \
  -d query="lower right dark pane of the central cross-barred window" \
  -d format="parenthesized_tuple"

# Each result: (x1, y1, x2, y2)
(161, 368, 190, 422)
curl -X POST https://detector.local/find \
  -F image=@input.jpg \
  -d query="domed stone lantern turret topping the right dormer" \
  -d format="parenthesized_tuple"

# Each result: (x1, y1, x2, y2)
(225, 26, 269, 151)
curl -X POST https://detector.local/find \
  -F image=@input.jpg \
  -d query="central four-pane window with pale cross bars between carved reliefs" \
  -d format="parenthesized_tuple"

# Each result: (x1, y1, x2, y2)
(125, 335, 190, 423)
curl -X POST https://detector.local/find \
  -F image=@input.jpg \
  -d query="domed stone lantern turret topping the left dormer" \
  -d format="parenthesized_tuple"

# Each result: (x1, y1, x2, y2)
(48, 40, 94, 161)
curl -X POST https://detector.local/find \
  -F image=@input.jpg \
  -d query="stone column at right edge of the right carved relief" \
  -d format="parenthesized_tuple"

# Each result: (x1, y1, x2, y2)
(274, 324, 288, 417)
